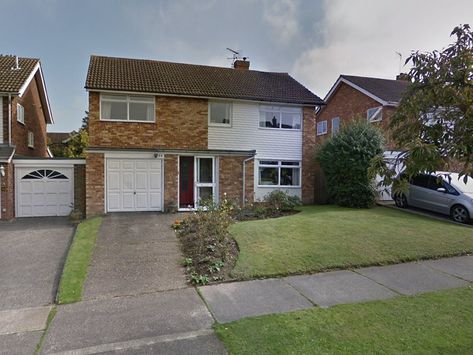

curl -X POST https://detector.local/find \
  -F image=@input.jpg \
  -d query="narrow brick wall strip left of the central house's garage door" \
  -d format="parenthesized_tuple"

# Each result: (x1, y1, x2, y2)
(85, 153, 105, 217)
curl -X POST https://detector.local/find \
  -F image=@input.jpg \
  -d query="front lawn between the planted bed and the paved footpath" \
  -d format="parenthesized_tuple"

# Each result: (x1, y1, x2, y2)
(230, 206, 473, 279)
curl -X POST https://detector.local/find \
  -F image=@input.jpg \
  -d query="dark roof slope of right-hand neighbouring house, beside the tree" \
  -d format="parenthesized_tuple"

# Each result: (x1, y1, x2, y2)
(340, 75, 410, 103)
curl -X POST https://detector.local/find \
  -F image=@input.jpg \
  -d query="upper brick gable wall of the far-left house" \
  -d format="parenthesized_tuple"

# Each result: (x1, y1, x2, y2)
(10, 75, 48, 157)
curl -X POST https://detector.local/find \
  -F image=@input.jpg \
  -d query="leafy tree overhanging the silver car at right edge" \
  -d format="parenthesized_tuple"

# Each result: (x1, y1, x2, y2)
(371, 25, 473, 191)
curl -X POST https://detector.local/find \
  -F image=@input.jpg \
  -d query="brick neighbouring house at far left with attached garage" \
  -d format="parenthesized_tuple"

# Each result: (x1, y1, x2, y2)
(0, 56, 85, 219)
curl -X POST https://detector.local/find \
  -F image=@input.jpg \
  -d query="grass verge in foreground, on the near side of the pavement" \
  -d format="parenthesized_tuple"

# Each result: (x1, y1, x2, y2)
(215, 287, 473, 354)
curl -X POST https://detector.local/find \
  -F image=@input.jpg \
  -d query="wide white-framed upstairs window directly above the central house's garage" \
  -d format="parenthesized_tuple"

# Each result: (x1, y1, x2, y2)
(100, 95, 155, 122)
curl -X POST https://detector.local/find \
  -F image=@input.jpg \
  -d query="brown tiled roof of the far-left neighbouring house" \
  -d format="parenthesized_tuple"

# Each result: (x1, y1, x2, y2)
(0, 55, 39, 94)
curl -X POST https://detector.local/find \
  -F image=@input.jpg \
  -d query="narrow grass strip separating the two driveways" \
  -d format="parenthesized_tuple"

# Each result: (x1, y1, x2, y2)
(57, 217, 102, 304)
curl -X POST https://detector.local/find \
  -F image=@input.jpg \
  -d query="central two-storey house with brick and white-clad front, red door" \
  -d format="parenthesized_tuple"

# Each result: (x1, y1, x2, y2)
(85, 56, 323, 216)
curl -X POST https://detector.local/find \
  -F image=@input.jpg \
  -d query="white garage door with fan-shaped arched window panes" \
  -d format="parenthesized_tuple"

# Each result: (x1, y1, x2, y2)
(15, 167, 74, 217)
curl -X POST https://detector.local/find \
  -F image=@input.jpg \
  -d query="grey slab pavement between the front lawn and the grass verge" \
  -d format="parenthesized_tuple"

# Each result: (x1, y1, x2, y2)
(199, 256, 473, 323)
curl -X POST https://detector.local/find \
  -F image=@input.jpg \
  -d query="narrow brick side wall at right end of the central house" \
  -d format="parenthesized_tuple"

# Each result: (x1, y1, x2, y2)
(302, 107, 315, 204)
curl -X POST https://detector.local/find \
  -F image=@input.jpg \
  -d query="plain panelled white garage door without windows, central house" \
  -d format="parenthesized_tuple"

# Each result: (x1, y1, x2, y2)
(106, 159, 162, 212)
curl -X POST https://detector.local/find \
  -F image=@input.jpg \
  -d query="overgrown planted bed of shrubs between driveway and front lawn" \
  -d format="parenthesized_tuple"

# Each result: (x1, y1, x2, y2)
(172, 199, 238, 285)
